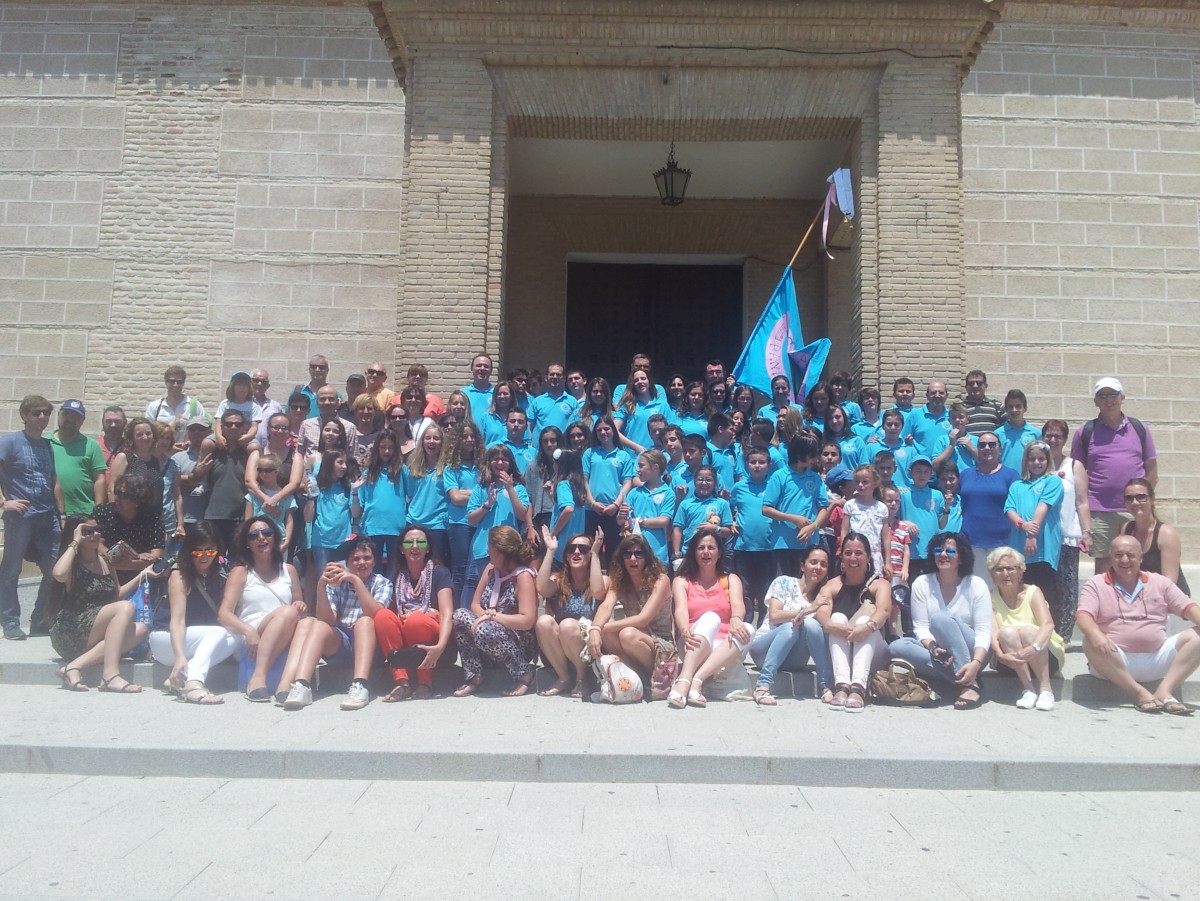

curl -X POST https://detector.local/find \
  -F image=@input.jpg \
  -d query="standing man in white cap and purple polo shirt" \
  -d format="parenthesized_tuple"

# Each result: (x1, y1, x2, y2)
(1070, 377, 1158, 573)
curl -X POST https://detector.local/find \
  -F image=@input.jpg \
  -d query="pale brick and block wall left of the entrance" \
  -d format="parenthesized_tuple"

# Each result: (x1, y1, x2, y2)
(0, 2, 404, 431)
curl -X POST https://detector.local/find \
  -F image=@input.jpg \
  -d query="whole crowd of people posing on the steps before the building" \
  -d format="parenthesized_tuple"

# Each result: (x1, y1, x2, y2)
(0, 354, 1200, 715)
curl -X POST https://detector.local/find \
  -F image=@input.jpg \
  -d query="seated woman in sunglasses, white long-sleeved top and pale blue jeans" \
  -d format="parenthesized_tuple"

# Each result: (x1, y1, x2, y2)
(890, 531, 992, 710)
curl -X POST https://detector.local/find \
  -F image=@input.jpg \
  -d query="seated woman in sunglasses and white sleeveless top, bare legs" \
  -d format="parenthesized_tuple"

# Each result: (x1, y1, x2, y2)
(217, 516, 308, 703)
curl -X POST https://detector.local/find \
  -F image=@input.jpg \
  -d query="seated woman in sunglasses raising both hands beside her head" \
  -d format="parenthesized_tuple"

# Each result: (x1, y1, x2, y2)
(534, 525, 608, 698)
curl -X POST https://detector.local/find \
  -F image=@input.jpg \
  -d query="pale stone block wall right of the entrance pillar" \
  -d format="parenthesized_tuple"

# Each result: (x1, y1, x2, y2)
(962, 4, 1200, 561)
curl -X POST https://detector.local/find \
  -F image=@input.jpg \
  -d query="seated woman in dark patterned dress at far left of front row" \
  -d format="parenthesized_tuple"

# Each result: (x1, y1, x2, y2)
(46, 516, 150, 695)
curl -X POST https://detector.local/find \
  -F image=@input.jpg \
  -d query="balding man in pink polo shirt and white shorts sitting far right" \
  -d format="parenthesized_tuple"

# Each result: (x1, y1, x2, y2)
(1076, 535, 1200, 716)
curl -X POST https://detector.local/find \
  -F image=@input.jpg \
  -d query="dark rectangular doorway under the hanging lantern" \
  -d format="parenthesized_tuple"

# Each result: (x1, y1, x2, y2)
(566, 263, 743, 389)
